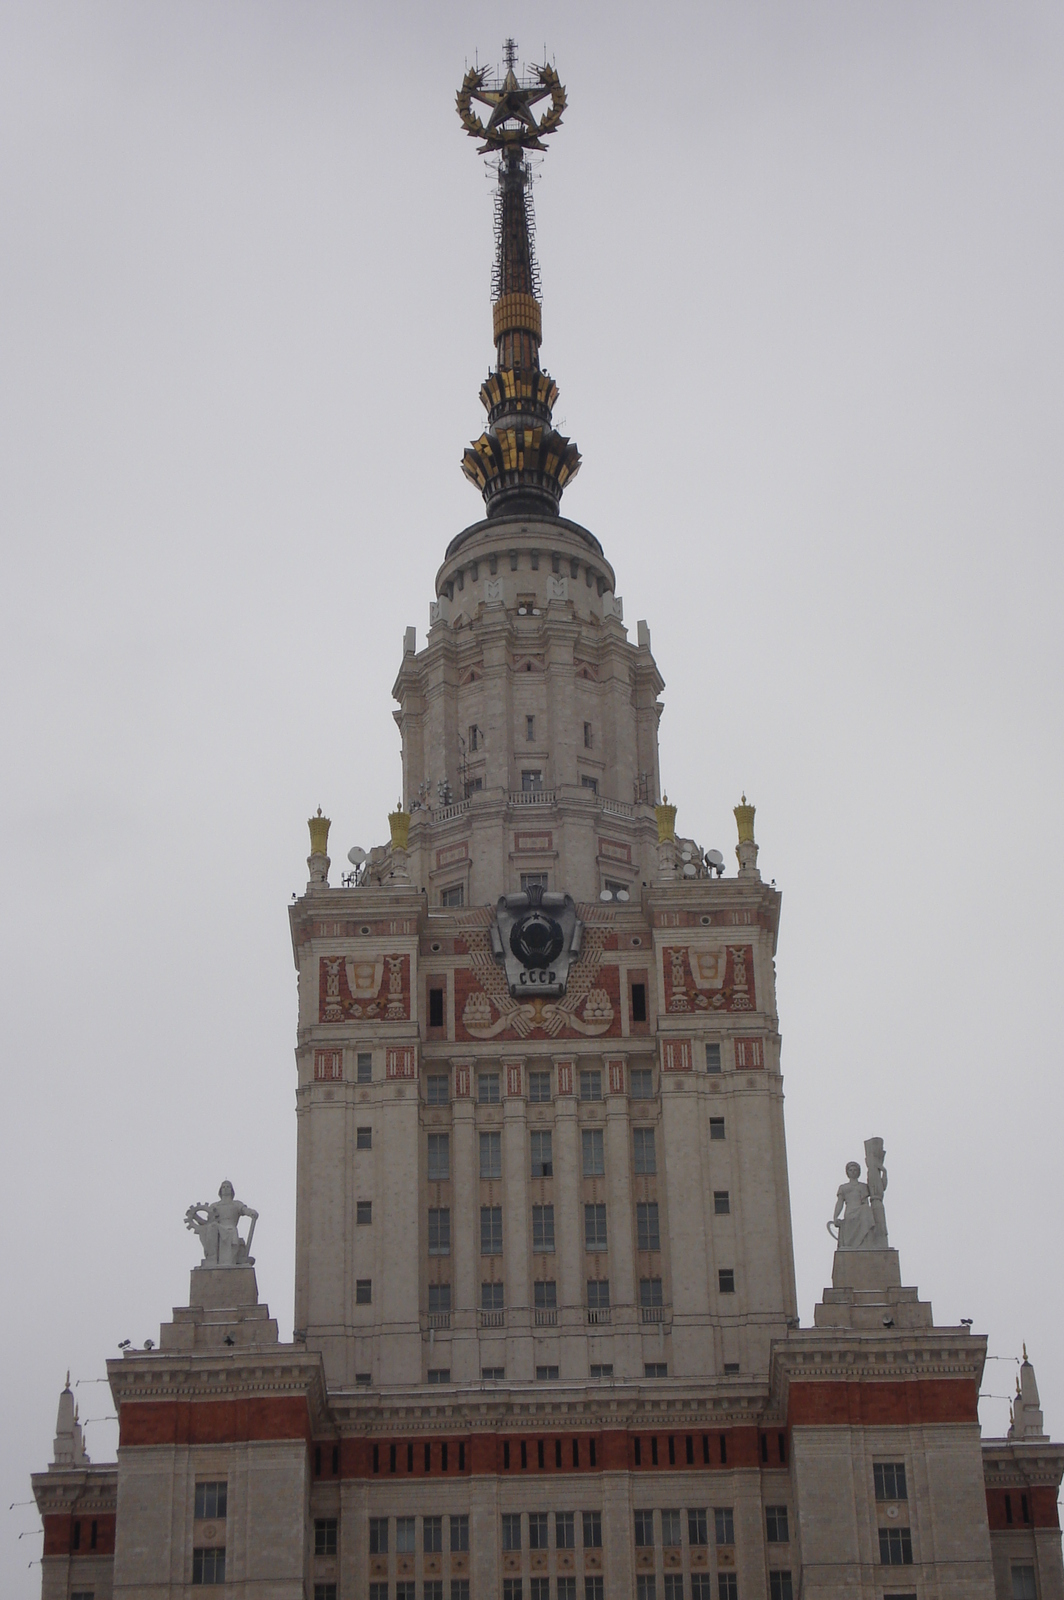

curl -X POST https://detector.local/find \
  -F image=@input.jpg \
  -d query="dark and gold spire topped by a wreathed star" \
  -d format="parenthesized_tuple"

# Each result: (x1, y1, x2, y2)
(458, 38, 581, 517)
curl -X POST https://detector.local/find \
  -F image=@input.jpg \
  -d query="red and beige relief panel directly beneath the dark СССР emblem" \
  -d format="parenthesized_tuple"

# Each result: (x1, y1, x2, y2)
(454, 925, 621, 1040)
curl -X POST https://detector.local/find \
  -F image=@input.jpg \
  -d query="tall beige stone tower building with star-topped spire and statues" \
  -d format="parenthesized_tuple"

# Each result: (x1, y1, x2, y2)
(34, 37, 1064, 1600)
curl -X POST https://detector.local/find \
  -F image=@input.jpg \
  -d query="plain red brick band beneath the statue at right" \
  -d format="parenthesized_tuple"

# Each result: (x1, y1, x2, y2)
(787, 1378, 979, 1427)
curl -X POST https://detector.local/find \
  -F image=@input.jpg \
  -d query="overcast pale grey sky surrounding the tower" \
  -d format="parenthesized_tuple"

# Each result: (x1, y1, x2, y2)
(0, 0, 1064, 1600)
